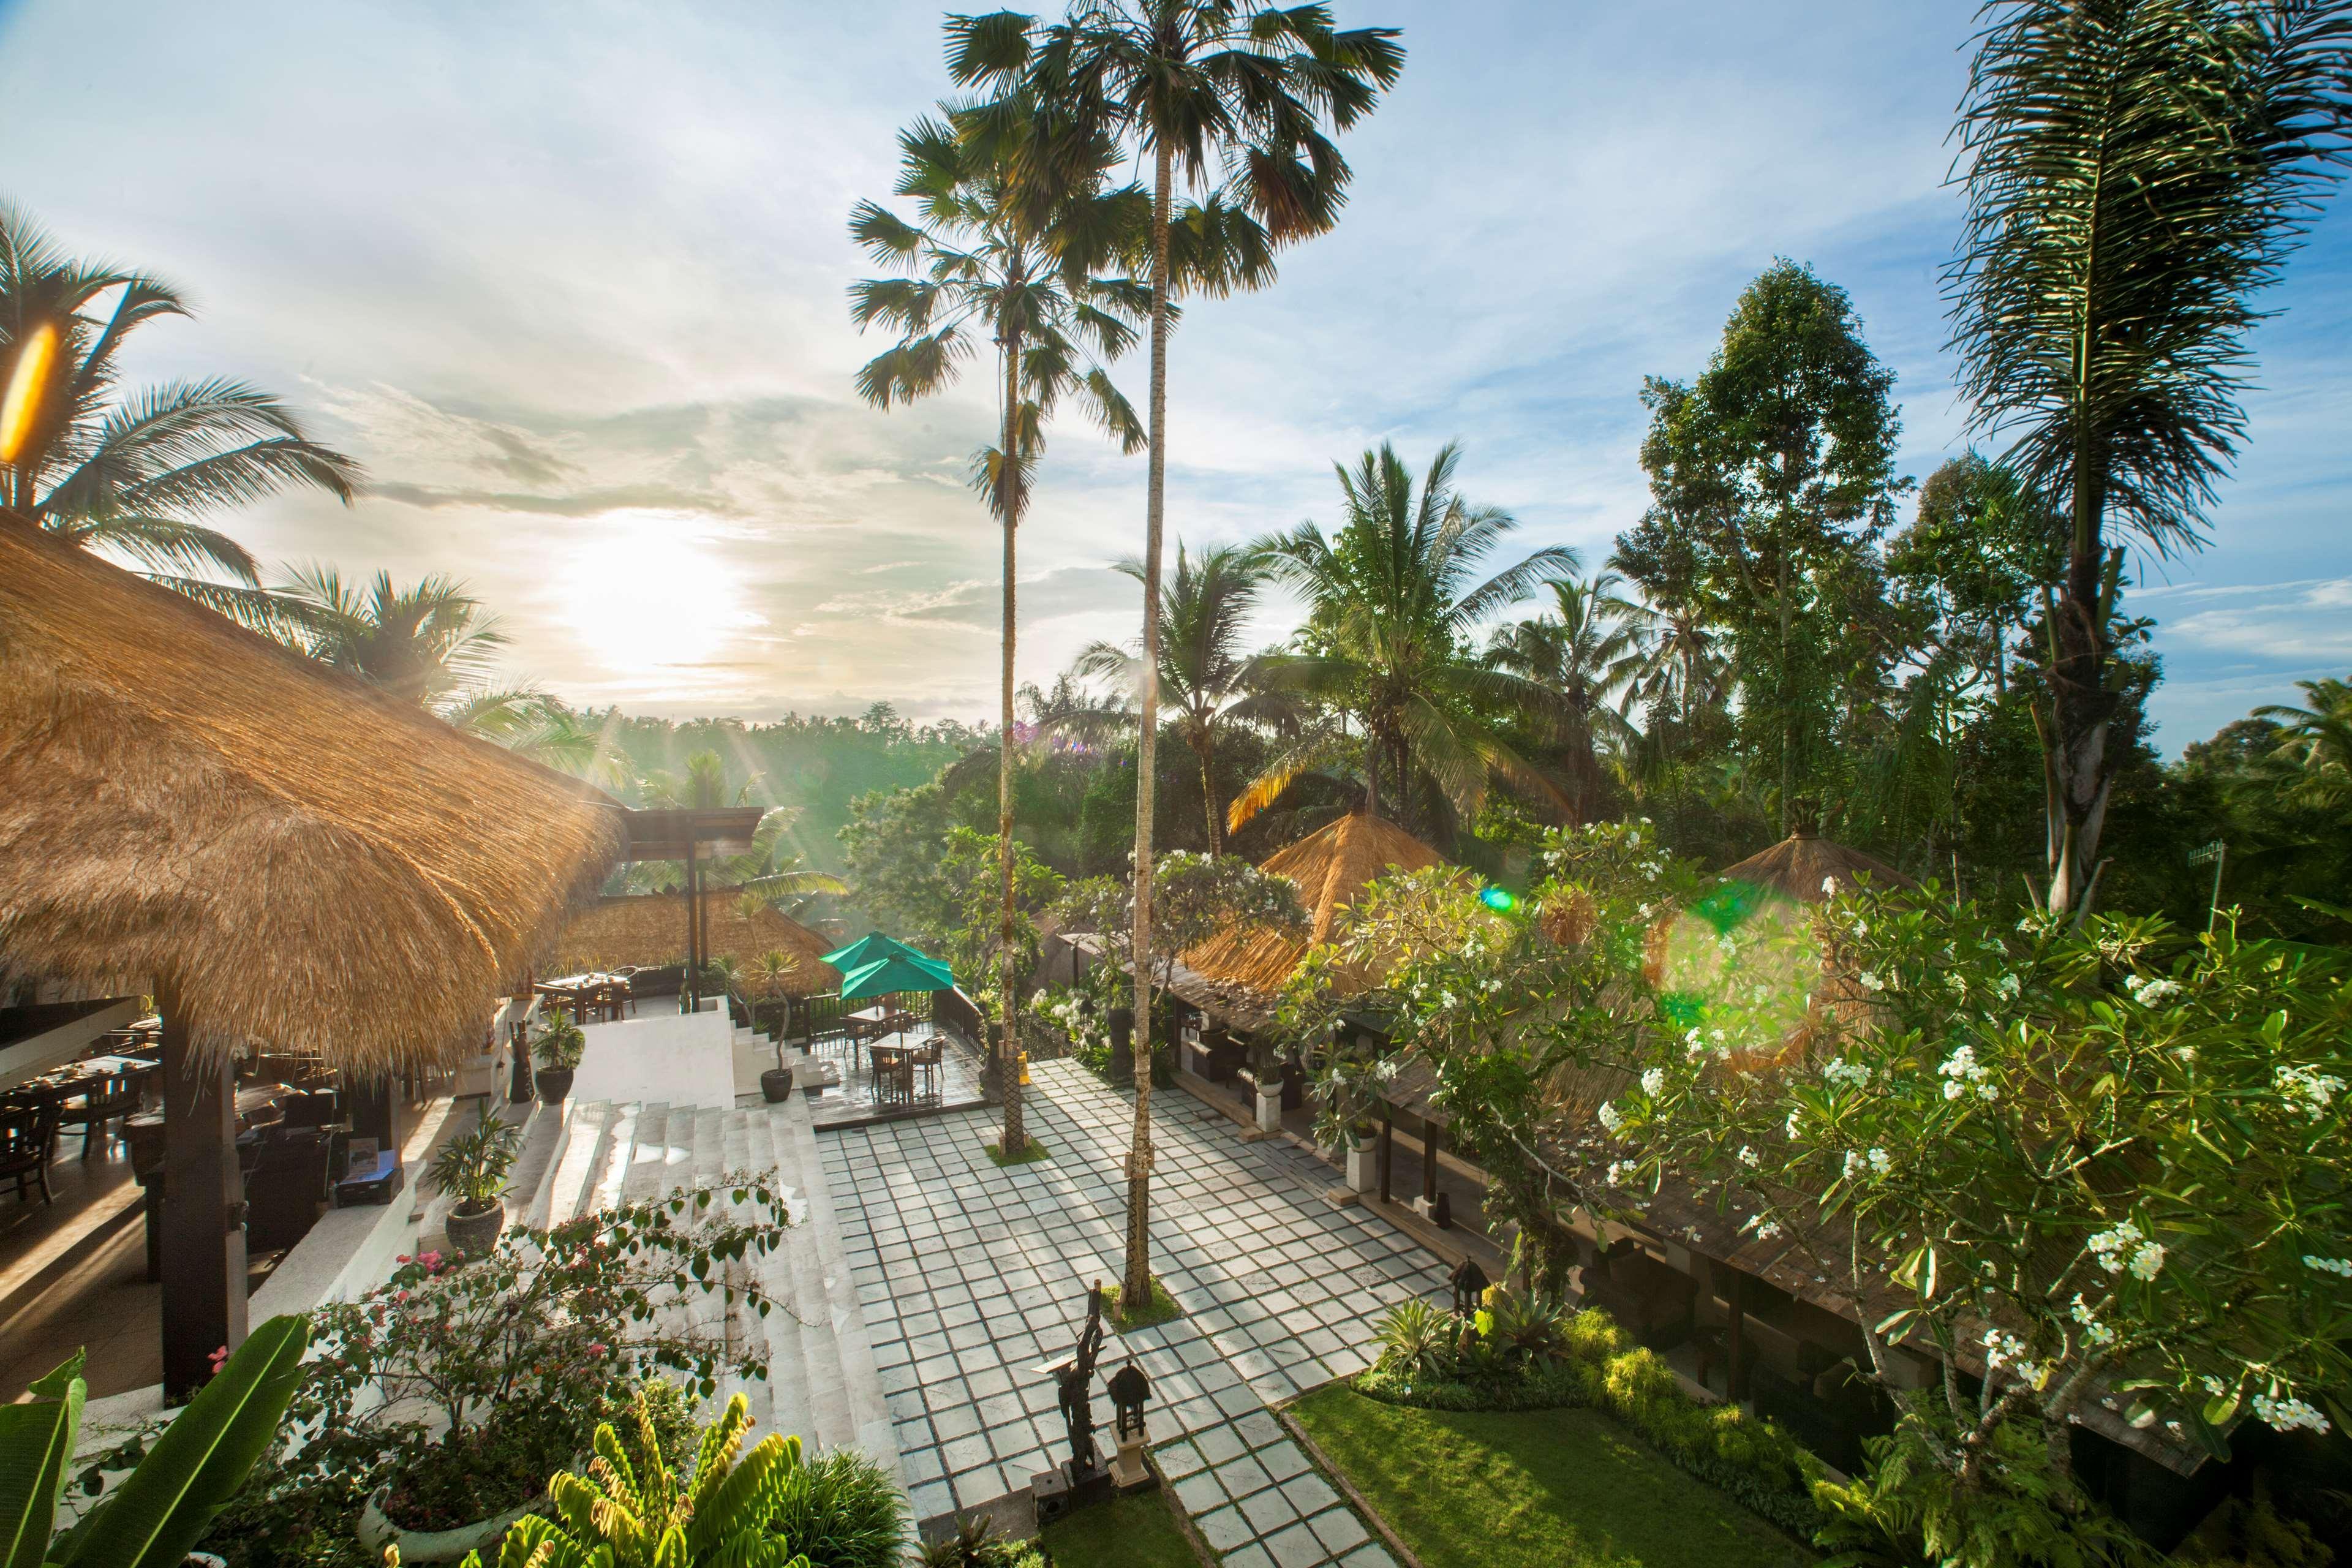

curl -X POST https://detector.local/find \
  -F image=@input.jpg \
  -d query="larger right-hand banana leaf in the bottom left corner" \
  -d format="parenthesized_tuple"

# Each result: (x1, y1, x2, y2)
(50, 1316, 311, 1568)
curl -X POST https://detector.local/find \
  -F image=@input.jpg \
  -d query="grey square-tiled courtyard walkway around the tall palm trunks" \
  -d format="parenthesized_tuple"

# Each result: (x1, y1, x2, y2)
(821, 1063, 1444, 1568)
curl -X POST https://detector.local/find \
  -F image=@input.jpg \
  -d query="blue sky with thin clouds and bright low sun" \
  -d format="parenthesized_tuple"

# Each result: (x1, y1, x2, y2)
(0, 0, 2352, 748)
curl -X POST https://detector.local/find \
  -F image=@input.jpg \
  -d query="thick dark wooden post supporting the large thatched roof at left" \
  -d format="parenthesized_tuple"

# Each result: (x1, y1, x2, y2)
(155, 995, 244, 1403)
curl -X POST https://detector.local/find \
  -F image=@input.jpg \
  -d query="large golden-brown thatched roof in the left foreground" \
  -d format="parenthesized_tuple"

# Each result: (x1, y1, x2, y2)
(0, 515, 624, 1072)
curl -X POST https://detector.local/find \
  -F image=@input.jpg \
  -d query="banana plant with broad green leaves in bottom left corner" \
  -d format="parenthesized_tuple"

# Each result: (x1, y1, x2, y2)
(0, 1316, 311, 1568)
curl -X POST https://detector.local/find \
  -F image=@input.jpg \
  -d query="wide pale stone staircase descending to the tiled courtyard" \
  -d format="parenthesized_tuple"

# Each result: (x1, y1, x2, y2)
(506, 1096, 903, 1486)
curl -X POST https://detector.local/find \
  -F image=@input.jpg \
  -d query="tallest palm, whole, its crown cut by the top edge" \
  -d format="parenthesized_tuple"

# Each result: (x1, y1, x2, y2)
(948, 0, 1404, 1302)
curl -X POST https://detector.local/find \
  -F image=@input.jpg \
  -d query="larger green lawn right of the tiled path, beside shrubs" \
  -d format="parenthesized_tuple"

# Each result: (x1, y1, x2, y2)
(1291, 1385, 1814, 1568)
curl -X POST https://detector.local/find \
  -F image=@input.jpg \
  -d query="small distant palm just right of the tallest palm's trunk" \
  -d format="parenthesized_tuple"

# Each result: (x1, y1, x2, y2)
(1075, 541, 1268, 856)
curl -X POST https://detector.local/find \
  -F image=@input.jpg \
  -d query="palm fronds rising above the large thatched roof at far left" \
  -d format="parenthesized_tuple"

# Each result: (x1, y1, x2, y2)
(0, 202, 360, 628)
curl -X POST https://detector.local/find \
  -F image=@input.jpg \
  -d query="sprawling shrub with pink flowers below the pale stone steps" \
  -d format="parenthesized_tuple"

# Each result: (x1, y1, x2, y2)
(266, 1175, 788, 1528)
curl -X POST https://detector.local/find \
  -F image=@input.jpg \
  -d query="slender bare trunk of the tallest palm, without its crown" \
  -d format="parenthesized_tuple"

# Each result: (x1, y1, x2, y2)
(1120, 141, 1176, 1312)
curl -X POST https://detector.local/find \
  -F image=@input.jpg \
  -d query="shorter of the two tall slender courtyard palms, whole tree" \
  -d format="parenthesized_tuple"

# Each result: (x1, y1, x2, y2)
(849, 104, 1145, 1154)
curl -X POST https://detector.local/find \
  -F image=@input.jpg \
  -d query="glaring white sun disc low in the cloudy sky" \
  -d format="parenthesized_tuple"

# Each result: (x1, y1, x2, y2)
(560, 513, 745, 675)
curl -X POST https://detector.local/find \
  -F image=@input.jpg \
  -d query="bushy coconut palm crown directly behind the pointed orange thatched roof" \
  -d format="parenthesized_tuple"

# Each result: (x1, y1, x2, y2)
(1230, 442, 1578, 827)
